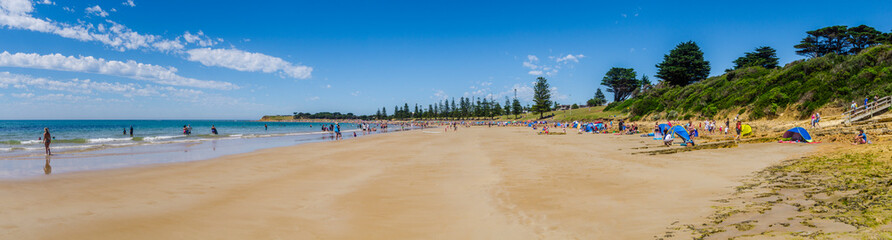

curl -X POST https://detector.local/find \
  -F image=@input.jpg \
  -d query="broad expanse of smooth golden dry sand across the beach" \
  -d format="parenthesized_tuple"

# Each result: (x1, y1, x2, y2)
(0, 127, 814, 239)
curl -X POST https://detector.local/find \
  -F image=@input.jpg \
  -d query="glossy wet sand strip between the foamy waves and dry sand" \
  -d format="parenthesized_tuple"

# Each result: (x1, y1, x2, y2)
(0, 126, 420, 180)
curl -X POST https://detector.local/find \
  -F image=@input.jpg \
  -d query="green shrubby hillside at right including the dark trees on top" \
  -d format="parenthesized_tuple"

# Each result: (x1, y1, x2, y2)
(607, 26, 892, 120)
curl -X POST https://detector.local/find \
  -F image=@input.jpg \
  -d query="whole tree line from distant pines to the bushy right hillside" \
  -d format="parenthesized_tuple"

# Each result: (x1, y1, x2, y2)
(294, 25, 892, 120)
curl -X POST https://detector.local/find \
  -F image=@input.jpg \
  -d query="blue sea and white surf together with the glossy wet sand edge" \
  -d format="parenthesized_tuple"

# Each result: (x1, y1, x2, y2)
(0, 120, 413, 179)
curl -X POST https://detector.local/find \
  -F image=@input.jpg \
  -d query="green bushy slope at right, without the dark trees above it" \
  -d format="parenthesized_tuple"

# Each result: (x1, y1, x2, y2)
(607, 45, 892, 120)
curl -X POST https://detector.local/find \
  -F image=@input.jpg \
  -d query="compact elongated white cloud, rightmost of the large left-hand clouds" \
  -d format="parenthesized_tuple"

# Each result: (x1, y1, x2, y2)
(186, 48, 313, 79)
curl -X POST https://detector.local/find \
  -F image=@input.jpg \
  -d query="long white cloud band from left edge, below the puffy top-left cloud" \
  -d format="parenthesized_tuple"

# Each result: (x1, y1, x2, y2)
(0, 51, 238, 90)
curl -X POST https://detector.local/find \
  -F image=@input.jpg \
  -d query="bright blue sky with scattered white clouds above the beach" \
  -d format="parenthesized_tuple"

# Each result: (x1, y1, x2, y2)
(0, 0, 892, 119)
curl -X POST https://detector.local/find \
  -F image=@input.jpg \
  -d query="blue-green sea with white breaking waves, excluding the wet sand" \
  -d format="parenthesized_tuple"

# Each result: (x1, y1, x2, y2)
(0, 120, 357, 156)
